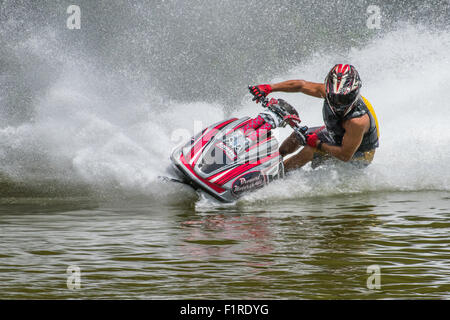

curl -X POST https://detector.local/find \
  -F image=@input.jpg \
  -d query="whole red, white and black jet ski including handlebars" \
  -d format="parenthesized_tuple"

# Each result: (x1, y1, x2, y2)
(165, 95, 308, 202)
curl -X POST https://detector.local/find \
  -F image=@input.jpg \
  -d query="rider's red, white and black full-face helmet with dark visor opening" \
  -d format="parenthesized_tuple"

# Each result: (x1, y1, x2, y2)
(325, 64, 362, 117)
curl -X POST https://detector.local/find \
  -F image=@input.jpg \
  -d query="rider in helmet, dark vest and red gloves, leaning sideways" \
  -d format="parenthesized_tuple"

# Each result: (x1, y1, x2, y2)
(249, 64, 379, 171)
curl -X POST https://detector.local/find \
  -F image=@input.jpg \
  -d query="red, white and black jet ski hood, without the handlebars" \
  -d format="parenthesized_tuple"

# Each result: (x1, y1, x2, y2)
(171, 117, 283, 202)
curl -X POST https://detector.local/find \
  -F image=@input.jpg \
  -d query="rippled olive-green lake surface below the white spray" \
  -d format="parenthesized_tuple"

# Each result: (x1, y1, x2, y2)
(0, 191, 450, 299)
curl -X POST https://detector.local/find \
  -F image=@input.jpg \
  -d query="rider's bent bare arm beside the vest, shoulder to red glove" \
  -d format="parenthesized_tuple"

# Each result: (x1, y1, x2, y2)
(321, 115, 370, 162)
